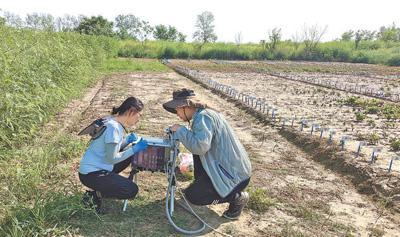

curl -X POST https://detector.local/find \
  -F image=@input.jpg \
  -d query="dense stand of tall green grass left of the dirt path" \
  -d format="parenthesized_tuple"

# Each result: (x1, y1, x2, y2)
(0, 27, 117, 151)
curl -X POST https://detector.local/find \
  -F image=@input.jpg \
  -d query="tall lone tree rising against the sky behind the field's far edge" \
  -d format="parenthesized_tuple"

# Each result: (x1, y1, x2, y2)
(193, 11, 217, 45)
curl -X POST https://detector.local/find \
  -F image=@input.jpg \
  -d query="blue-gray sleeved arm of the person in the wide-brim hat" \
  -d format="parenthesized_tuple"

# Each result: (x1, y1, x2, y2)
(175, 116, 214, 155)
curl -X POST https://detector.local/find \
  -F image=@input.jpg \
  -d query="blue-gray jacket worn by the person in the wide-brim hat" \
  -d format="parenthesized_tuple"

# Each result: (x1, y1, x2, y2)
(175, 109, 251, 198)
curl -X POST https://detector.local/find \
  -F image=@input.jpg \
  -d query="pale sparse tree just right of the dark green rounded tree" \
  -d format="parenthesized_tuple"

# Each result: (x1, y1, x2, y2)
(115, 14, 142, 40)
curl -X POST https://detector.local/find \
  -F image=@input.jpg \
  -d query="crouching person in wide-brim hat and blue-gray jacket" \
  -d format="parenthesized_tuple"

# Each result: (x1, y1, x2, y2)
(163, 89, 251, 219)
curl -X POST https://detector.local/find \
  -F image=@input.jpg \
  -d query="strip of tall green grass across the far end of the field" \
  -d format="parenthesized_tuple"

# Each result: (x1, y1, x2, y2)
(118, 40, 400, 66)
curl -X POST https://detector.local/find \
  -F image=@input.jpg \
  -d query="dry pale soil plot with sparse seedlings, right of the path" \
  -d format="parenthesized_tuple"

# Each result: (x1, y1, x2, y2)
(173, 60, 400, 172)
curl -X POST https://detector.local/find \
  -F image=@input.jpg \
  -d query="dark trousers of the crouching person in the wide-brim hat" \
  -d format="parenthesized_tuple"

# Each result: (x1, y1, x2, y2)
(185, 155, 250, 206)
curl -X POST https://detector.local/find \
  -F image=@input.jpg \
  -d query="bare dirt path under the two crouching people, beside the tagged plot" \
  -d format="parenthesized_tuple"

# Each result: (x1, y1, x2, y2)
(68, 73, 400, 236)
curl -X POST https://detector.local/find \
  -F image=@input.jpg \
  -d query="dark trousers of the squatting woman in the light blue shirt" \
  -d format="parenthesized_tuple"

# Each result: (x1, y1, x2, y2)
(79, 158, 139, 199)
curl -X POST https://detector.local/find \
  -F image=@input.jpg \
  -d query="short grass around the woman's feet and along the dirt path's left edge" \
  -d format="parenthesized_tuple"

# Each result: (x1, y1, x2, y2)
(0, 56, 170, 236)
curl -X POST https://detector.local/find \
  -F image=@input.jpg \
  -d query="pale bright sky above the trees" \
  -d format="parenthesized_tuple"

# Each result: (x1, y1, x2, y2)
(0, 0, 400, 43)
